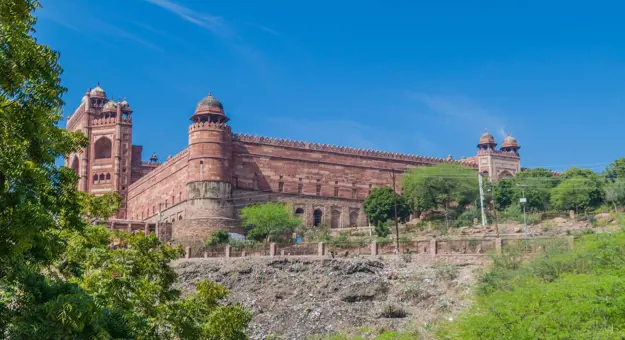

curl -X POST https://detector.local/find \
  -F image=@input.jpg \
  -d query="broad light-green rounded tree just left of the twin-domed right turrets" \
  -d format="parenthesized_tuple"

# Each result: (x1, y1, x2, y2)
(402, 163, 479, 224)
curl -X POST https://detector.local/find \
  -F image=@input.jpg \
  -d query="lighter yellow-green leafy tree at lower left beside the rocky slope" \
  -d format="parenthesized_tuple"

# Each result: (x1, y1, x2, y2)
(57, 227, 250, 339)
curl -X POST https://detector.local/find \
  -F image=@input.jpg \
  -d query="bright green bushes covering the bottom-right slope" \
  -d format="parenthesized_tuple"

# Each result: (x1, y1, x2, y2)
(439, 231, 625, 339)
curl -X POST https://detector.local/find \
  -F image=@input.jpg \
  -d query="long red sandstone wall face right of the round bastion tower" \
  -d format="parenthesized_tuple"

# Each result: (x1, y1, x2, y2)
(233, 142, 440, 201)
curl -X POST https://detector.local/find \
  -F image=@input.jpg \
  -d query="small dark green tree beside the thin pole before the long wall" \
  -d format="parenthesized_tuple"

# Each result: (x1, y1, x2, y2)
(363, 187, 410, 237)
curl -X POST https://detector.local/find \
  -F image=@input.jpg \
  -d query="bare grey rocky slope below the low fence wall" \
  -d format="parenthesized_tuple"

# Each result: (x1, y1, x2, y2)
(173, 257, 476, 339)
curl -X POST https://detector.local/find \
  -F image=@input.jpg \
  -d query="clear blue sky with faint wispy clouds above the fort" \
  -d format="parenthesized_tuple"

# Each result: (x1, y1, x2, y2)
(37, 0, 625, 171)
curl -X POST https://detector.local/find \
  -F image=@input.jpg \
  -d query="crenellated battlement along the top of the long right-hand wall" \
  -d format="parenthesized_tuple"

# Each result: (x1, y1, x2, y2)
(232, 133, 474, 167)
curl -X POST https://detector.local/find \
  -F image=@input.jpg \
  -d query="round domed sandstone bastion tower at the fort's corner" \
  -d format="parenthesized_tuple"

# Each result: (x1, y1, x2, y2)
(178, 94, 241, 241)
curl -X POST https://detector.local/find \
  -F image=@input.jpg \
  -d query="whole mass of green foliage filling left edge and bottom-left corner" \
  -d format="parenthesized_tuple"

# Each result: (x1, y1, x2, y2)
(0, 0, 250, 339)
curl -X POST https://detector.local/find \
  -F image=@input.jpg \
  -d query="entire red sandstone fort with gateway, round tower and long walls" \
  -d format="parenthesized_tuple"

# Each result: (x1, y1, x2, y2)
(65, 85, 520, 240)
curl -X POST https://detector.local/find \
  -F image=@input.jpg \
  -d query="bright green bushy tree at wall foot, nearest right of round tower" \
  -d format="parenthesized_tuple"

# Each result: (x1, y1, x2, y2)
(239, 202, 302, 241)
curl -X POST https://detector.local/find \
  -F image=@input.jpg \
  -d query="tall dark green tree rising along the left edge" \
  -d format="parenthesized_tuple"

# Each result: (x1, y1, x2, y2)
(0, 0, 92, 339)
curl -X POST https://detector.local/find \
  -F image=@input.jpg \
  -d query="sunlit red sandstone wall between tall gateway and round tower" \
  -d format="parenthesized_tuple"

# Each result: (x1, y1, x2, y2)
(128, 149, 188, 222)
